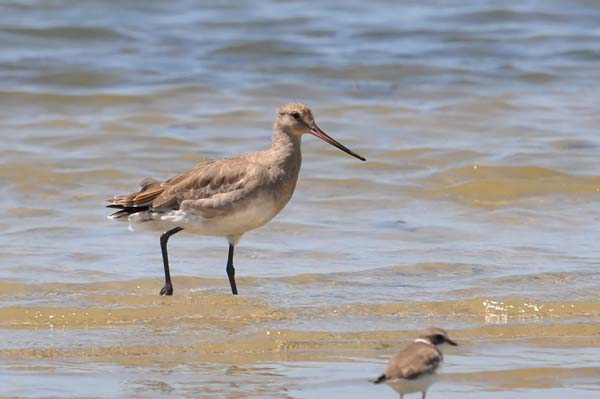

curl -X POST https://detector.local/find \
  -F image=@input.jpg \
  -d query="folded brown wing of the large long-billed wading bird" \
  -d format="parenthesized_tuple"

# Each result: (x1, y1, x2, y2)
(108, 157, 266, 217)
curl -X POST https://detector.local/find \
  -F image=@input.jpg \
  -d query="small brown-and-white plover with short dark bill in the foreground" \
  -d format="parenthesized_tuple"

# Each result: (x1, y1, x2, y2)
(372, 327, 457, 399)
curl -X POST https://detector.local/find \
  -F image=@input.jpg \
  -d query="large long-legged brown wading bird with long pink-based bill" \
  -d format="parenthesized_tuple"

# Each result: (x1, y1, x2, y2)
(108, 103, 366, 295)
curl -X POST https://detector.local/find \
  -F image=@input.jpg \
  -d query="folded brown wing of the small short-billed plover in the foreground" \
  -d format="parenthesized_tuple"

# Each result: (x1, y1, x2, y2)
(385, 342, 443, 380)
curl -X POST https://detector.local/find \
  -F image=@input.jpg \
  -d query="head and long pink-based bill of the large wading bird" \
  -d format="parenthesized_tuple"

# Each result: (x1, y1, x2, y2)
(275, 103, 366, 161)
